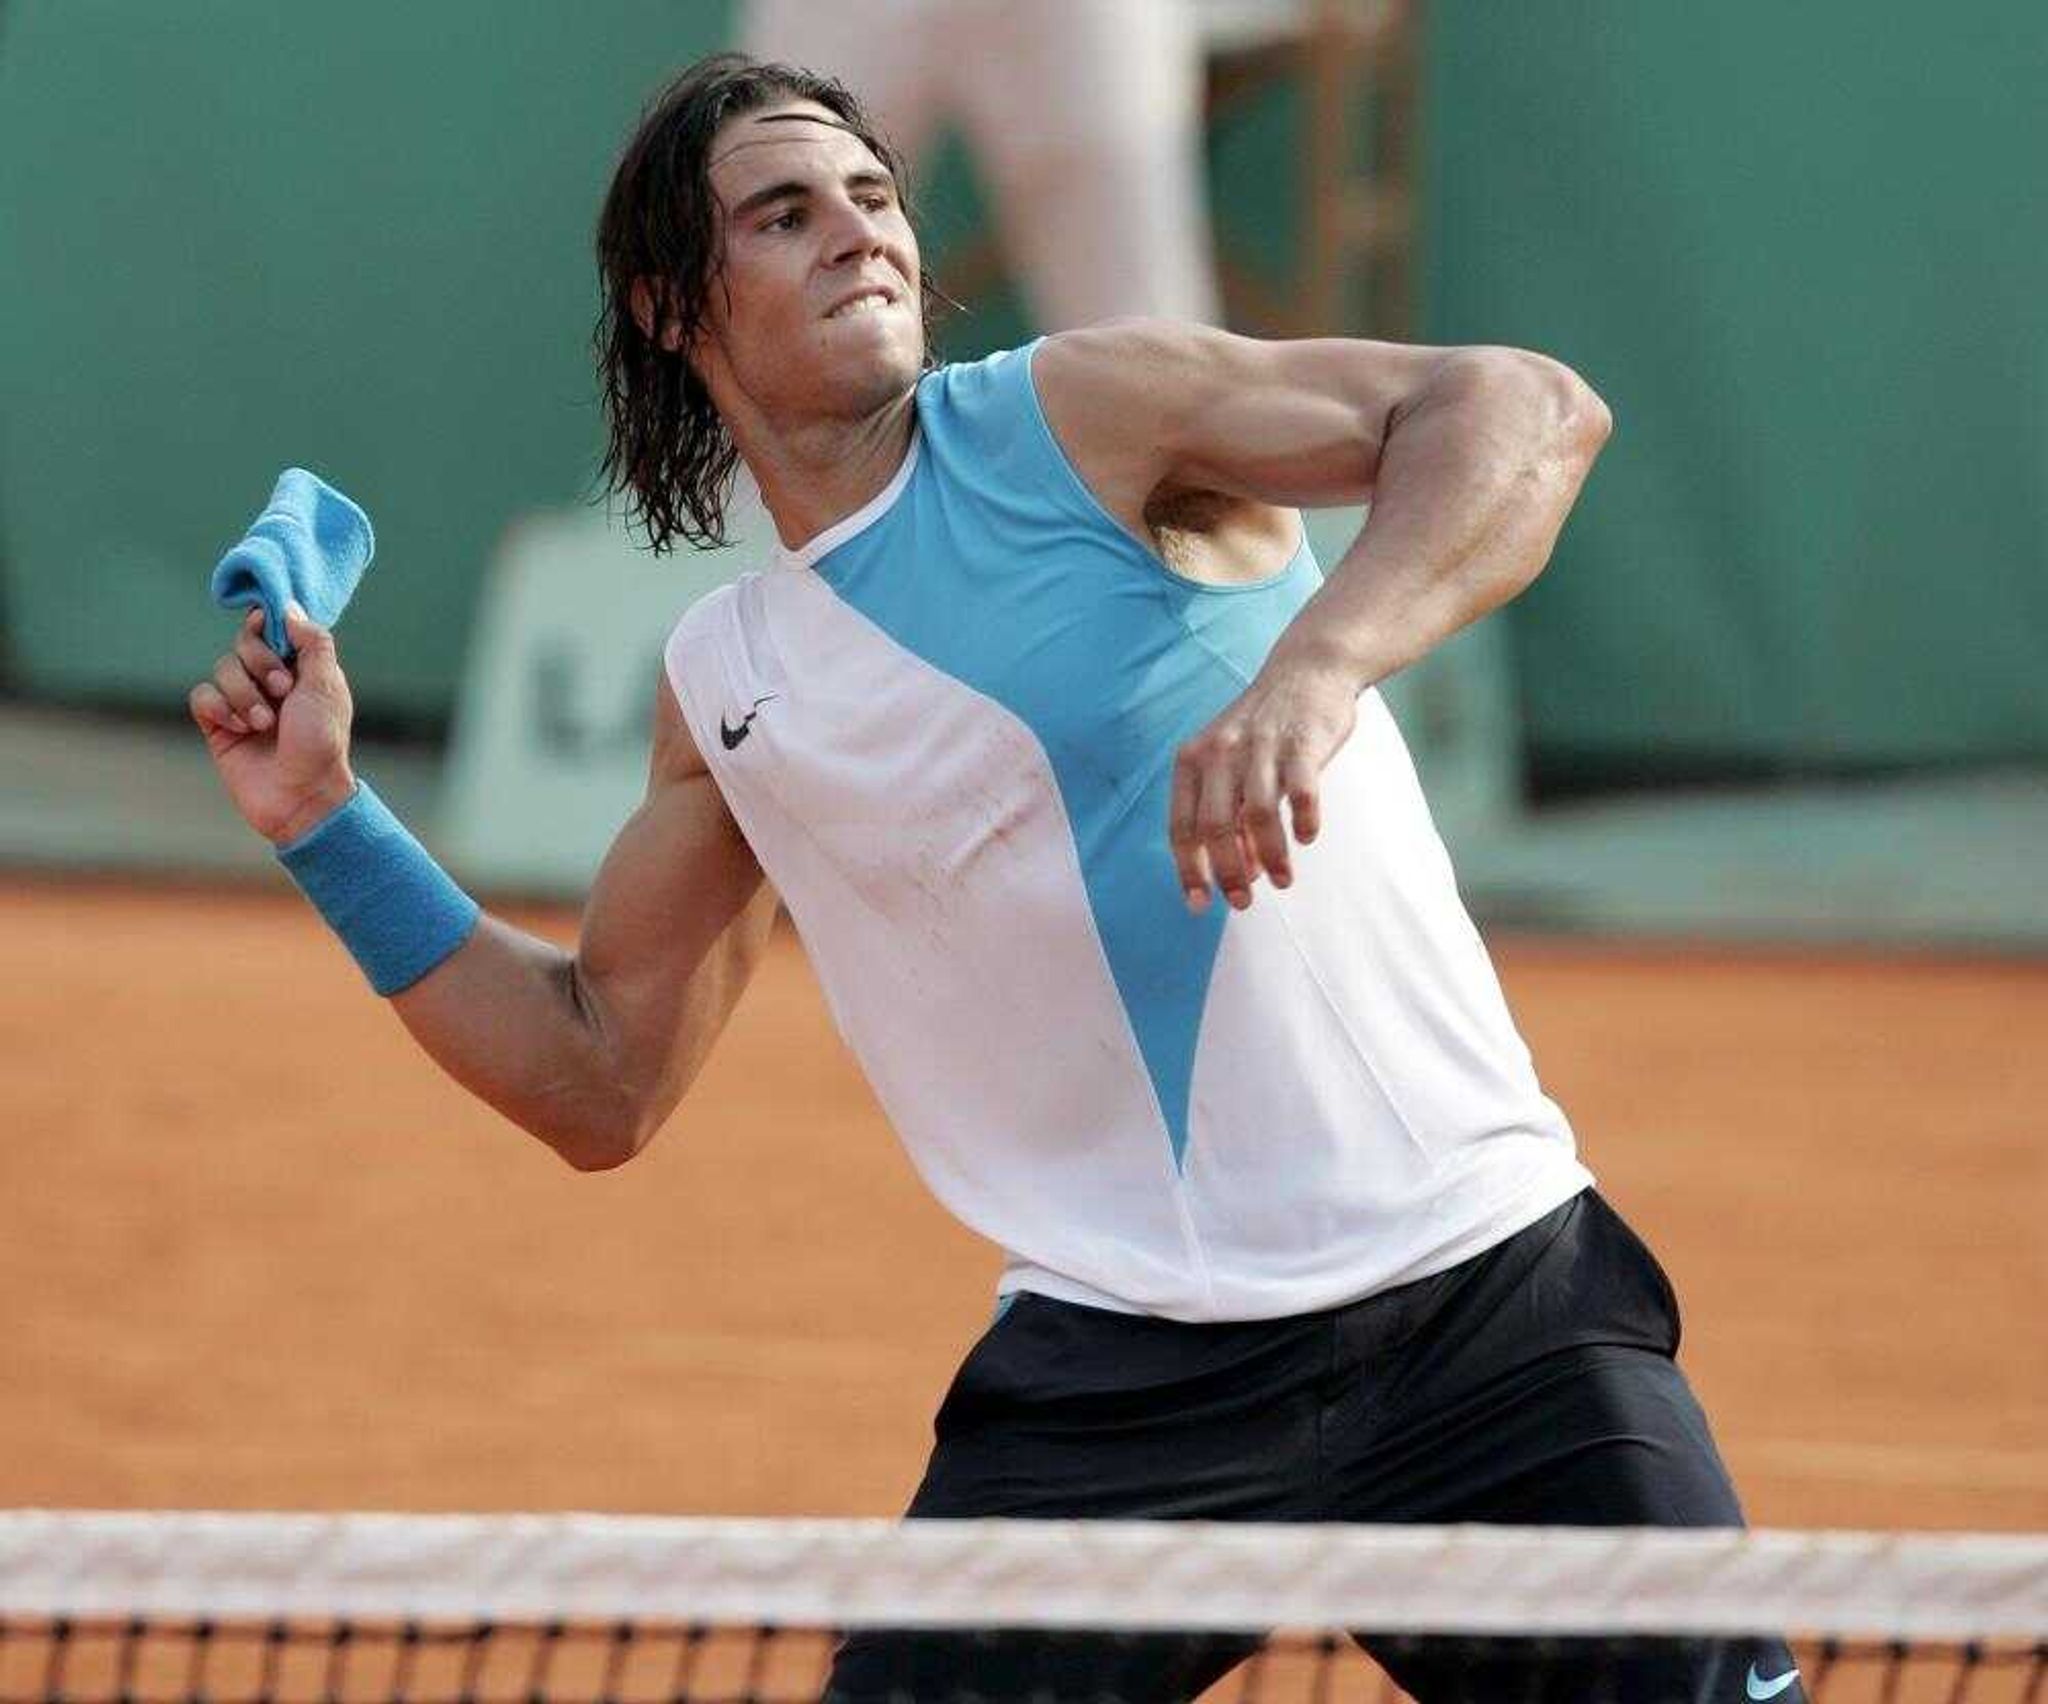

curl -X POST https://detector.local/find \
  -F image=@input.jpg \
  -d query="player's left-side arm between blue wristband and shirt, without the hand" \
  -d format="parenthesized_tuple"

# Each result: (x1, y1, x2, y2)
(391, 680, 776, 1169)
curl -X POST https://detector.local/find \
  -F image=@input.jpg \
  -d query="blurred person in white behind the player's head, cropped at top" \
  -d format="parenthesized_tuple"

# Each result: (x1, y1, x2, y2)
(741, 0, 1221, 330)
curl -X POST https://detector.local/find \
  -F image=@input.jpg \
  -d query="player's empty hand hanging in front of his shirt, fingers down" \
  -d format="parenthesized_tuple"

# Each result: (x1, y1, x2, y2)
(1167, 655, 1358, 911)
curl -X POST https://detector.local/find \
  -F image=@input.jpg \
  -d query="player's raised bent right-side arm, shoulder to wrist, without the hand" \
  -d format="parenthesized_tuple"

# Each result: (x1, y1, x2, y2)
(1034, 322, 1610, 690)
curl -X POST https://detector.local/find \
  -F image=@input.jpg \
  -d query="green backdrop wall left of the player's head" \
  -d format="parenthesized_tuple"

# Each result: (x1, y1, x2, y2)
(0, 0, 727, 715)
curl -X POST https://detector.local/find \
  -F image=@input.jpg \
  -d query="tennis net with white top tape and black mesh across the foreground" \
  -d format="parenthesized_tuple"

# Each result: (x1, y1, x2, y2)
(0, 1511, 2048, 1704)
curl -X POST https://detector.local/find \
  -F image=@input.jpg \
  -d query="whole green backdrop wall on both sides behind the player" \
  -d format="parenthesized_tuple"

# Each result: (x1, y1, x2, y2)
(0, 0, 2048, 768)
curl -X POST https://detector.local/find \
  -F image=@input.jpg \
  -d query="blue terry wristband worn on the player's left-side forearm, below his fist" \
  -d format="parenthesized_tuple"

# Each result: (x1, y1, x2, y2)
(276, 780, 481, 993)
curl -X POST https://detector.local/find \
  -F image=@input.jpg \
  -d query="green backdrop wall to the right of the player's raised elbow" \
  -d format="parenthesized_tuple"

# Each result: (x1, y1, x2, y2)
(1427, 0, 2048, 768)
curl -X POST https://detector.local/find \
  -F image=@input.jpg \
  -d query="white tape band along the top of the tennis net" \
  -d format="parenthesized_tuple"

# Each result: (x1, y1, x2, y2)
(0, 1511, 2048, 1638)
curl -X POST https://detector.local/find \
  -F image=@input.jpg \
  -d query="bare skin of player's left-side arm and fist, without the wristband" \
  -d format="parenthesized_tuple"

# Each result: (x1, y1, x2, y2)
(186, 606, 774, 1169)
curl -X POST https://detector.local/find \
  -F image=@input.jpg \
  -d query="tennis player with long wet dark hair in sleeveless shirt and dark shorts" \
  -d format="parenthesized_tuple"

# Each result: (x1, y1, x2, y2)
(190, 55, 1798, 1700)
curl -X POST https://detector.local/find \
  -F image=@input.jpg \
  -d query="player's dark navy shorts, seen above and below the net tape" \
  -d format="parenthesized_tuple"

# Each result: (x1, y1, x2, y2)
(829, 1190, 1800, 1704)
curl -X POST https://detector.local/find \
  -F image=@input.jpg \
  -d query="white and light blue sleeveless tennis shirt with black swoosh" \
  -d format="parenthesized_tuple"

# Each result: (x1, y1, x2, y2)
(666, 346, 1591, 1321)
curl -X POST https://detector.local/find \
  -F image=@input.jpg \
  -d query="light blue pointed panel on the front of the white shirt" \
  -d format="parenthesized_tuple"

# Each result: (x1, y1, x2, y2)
(815, 344, 1321, 1165)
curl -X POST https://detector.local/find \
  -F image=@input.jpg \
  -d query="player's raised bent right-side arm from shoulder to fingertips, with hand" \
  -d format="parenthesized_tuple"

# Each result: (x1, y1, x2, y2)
(1034, 322, 1610, 909)
